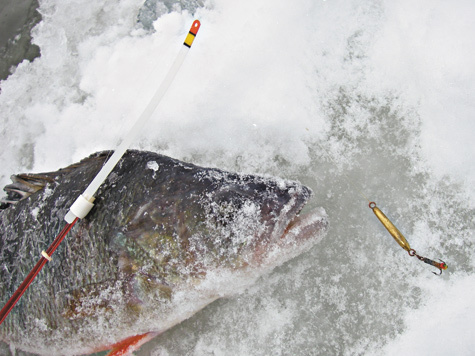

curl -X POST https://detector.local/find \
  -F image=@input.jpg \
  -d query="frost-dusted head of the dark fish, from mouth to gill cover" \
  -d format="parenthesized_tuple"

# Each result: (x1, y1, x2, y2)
(107, 156, 327, 332)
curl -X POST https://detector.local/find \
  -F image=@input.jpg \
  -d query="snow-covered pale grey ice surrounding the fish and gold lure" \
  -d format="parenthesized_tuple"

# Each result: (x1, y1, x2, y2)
(0, 0, 475, 356)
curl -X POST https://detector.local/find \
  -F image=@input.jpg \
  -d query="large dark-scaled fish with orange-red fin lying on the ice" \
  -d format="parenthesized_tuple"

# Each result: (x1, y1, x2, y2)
(0, 151, 327, 355)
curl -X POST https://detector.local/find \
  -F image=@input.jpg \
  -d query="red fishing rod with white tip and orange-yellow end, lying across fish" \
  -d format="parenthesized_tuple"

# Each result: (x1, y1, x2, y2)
(0, 20, 201, 325)
